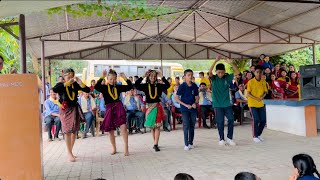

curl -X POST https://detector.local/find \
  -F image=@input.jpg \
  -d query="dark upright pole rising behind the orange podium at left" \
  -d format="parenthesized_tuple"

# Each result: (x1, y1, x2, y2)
(19, 14, 27, 74)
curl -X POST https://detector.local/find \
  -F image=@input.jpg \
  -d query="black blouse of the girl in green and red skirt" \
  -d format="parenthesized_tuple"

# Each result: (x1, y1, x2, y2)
(134, 77, 170, 103)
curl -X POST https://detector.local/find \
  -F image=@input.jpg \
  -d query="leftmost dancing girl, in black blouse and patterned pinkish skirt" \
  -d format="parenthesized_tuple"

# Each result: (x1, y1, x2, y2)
(52, 68, 90, 162)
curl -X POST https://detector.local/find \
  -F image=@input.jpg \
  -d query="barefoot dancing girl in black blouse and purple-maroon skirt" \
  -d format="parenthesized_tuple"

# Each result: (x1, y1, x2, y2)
(94, 69, 133, 156)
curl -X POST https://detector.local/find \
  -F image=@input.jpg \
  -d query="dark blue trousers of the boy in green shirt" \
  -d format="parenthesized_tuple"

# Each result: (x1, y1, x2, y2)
(214, 106, 234, 141)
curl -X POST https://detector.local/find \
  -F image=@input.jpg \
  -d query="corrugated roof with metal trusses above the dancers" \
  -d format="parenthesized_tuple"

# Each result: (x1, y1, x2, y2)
(15, 0, 320, 60)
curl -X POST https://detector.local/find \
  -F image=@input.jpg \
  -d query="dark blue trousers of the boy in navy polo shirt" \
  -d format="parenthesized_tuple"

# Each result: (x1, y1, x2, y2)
(181, 111, 197, 146)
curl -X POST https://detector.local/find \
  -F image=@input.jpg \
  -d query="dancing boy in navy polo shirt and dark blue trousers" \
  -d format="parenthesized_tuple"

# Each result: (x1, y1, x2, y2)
(176, 69, 199, 151)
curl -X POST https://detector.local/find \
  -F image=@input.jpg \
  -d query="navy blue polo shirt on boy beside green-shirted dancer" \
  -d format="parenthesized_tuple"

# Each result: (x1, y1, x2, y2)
(177, 82, 199, 112)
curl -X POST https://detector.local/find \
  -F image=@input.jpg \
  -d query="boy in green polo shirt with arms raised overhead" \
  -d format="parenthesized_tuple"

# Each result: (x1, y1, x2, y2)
(209, 56, 240, 146)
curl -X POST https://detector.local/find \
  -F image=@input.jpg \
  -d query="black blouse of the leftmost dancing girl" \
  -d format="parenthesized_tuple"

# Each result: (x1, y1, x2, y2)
(52, 82, 90, 106)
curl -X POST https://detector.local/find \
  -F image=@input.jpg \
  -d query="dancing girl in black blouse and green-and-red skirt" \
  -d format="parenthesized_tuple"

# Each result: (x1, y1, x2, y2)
(135, 70, 170, 152)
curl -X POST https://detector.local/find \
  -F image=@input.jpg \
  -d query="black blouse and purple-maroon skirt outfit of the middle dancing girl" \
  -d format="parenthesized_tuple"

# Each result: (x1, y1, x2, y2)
(94, 77, 133, 132)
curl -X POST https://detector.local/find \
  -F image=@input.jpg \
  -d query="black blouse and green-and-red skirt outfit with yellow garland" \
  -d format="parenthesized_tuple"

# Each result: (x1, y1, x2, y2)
(135, 77, 170, 128)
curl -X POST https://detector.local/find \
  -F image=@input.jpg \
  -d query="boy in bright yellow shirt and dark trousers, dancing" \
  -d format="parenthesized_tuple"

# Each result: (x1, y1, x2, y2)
(247, 65, 268, 143)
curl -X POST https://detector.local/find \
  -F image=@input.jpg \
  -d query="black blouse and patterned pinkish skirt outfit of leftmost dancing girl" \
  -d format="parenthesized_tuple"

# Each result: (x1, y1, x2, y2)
(53, 82, 90, 134)
